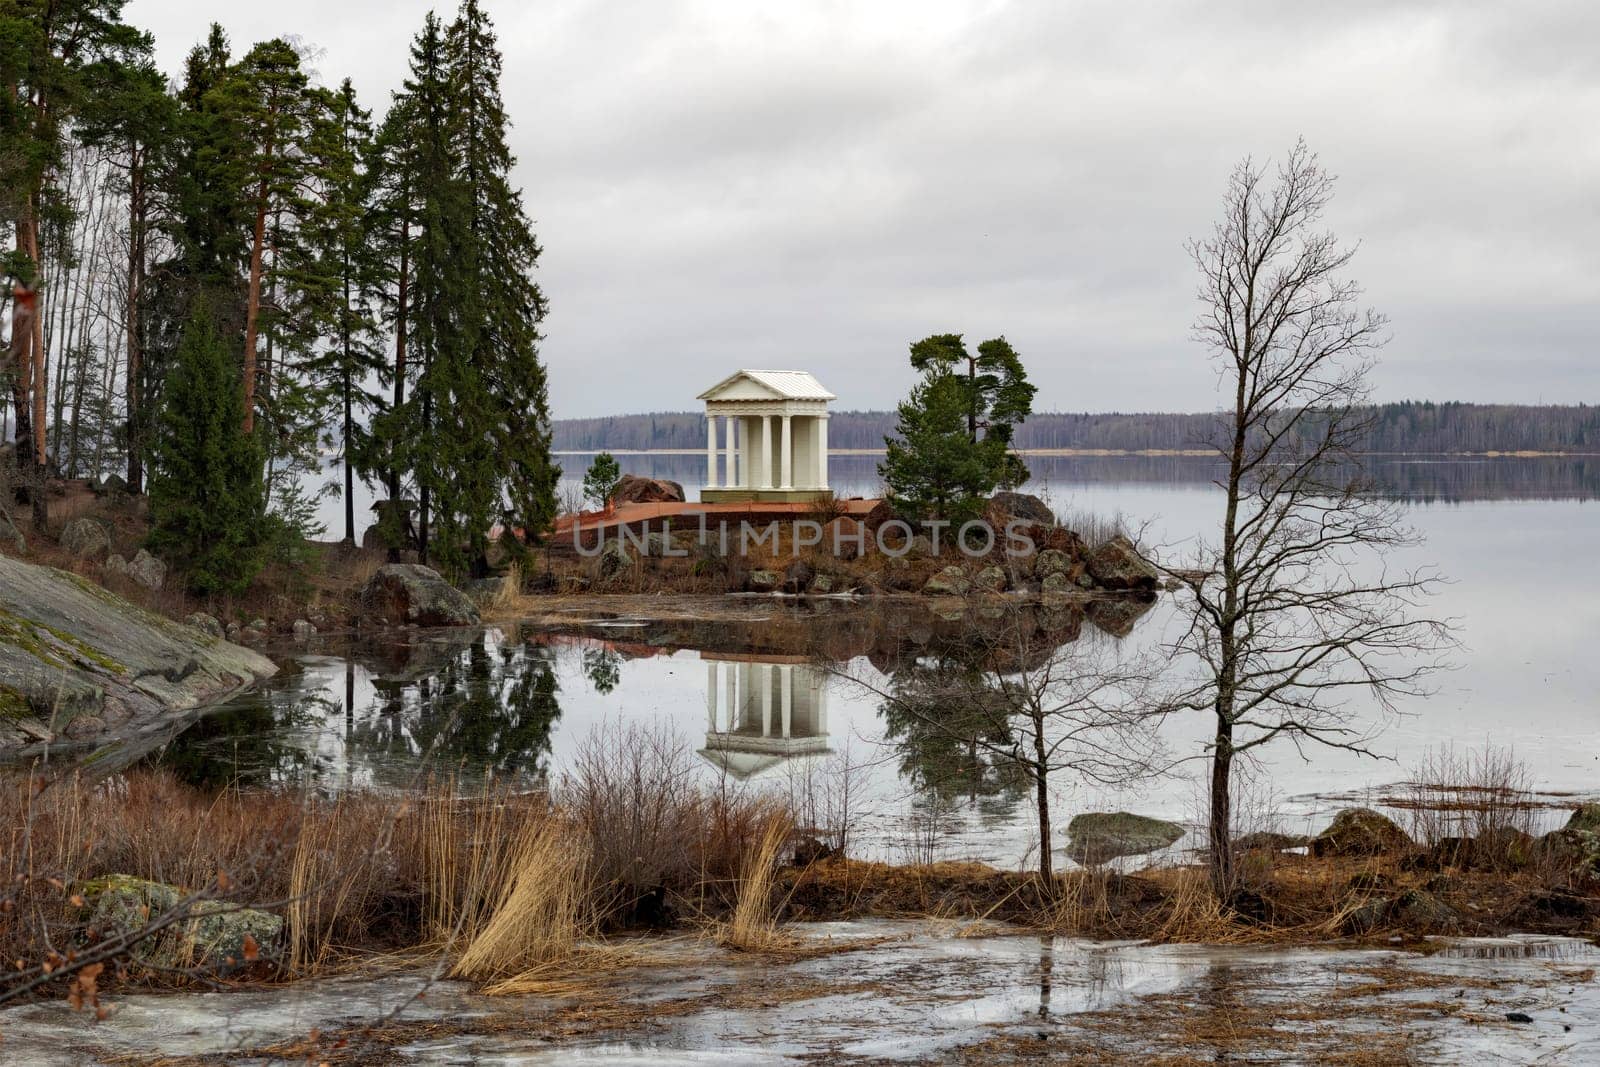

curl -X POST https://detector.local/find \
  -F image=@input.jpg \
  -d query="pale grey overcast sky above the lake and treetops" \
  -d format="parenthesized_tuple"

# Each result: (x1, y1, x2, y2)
(126, 0, 1600, 418)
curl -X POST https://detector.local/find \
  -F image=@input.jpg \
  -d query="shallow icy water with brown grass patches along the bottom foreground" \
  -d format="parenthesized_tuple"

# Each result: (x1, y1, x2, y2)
(0, 921, 1600, 1067)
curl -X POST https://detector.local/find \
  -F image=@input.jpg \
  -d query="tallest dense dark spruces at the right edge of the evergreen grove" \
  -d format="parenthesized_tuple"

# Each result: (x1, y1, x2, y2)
(374, 0, 560, 585)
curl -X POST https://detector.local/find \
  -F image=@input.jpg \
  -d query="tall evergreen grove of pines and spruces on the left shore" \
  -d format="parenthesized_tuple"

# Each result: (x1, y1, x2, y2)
(0, 0, 558, 592)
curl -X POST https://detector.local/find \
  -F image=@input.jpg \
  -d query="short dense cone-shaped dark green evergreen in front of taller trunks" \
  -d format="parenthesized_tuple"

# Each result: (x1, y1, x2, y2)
(149, 296, 266, 595)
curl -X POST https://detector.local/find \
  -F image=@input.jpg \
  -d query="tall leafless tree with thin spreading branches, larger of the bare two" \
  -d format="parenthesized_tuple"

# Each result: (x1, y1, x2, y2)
(1171, 141, 1450, 897)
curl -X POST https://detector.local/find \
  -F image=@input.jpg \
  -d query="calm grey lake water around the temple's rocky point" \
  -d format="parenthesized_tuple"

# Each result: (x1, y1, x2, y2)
(219, 456, 1600, 864)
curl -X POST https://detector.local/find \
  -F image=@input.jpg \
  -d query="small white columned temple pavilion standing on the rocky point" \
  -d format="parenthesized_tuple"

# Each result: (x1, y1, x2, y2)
(699, 371, 838, 502)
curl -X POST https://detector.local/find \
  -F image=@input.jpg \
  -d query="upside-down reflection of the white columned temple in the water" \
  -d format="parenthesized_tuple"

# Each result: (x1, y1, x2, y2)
(699, 653, 832, 781)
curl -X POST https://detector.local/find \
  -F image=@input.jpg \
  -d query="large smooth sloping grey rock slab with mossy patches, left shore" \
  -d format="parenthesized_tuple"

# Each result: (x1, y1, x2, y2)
(0, 557, 274, 750)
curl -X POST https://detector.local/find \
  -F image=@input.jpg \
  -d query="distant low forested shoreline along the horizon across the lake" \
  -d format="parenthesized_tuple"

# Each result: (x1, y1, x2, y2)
(552, 402, 1600, 453)
